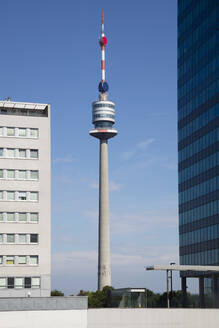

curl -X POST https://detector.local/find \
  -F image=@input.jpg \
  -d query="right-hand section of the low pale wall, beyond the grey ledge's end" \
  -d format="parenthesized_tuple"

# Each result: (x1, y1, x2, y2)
(87, 309, 219, 328)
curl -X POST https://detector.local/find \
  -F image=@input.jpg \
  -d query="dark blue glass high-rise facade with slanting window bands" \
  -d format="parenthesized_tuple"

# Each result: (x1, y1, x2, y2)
(178, 0, 219, 276)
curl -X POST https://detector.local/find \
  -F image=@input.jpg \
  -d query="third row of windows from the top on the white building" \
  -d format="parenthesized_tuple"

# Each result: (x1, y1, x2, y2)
(0, 169, 39, 180)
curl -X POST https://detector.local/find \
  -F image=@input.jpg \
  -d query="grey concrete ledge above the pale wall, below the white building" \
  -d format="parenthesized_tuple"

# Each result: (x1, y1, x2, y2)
(0, 296, 88, 311)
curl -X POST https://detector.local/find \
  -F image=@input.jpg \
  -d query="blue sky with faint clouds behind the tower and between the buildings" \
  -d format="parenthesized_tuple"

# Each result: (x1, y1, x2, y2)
(0, 0, 195, 294)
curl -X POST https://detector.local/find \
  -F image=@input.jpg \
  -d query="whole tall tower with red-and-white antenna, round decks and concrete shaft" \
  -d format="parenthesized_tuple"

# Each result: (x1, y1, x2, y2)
(90, 13, 117, 290)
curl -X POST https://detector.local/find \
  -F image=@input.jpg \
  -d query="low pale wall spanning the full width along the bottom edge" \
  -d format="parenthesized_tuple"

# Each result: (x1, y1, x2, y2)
(0, 309, 219, 328)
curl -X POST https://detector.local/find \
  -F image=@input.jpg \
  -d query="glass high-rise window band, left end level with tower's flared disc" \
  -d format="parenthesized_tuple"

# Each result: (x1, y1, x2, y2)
(178, 105, 219, 142)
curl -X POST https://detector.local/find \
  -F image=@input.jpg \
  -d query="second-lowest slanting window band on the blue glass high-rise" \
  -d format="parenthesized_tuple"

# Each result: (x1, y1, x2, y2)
(179, 224, 219, 247)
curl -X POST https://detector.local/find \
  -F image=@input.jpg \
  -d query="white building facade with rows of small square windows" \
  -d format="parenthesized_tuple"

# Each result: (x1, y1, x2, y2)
(0, 101, 51, 297)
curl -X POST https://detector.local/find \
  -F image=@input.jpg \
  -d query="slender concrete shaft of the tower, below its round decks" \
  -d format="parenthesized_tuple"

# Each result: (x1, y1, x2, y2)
(98, 139, 111, 290)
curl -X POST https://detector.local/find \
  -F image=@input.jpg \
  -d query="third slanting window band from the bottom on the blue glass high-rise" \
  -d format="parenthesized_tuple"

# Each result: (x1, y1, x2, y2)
(179, 200, 219, 225)
